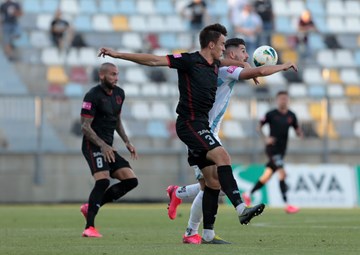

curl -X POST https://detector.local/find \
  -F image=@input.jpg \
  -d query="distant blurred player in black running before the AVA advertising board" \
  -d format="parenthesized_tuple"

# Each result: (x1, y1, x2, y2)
(243, 91, 303, 213)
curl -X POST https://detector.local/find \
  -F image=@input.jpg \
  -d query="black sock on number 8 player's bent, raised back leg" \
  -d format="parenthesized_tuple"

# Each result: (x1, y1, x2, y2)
(100, 178, 138, 206)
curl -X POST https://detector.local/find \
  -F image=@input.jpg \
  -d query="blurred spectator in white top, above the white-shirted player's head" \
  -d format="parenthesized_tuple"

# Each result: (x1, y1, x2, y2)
(234, 3, 263, 59)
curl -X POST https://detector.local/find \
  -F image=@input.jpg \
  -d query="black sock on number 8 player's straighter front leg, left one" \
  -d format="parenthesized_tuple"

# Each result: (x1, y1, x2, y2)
(85, 179, 110, 228)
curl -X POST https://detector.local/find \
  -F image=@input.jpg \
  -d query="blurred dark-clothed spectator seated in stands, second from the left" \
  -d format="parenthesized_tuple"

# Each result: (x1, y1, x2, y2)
(50, 9, 70, 50)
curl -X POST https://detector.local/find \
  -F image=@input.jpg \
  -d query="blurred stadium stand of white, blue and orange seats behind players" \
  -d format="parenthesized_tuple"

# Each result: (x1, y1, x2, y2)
(0, 0, 360, 153)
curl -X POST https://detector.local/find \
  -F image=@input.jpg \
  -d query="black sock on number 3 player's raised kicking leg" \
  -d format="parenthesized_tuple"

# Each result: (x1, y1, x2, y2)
(217, 165, 242, 207)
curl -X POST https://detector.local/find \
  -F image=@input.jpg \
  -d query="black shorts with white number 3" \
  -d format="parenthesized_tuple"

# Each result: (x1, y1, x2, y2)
(176, 118, 221, 169)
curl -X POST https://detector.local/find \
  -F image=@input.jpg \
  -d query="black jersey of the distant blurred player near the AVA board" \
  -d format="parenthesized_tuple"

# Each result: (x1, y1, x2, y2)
(260, 109, 299, 150)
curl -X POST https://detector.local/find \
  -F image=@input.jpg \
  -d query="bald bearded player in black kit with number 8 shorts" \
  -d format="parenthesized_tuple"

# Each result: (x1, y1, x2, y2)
(80, 63, 138, 237)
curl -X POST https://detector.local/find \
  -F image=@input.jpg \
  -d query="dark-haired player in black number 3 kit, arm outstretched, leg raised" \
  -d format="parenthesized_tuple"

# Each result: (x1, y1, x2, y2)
(99, 24, 265, 244)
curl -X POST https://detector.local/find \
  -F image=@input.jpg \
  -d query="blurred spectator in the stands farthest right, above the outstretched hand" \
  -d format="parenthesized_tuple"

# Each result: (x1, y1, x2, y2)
(297, 10, 317, 58)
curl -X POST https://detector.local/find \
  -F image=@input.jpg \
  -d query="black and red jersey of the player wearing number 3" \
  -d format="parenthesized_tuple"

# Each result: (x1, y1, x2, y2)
(167, 51, 220, 121)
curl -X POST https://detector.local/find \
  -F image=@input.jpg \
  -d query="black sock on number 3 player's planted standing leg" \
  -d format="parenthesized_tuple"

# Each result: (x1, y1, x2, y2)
(202, 186, 220, 229)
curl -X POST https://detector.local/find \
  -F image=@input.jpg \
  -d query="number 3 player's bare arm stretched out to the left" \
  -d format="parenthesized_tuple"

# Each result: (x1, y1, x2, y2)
(98, 47, 168, 66)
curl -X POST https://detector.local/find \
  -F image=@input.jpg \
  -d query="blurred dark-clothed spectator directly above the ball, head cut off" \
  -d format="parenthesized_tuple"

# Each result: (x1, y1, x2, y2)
(254, 0, 274, 45)
